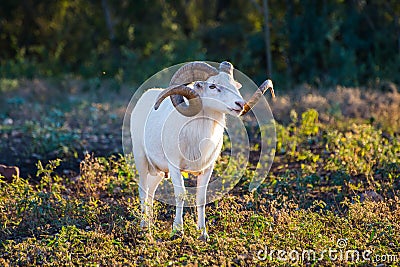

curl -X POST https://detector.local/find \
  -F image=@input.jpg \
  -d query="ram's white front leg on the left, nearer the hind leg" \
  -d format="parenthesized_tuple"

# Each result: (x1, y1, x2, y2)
(168, 164, 186, 236)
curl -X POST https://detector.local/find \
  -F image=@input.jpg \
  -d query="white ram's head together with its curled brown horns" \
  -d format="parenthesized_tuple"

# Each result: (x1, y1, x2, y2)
(154, 61, 274, 117)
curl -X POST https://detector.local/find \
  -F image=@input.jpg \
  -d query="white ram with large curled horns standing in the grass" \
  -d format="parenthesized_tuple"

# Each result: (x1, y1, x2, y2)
(130, 61, 273, 240)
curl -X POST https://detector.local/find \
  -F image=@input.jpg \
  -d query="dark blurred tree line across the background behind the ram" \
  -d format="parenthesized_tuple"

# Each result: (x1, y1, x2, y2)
(0, 0, 400, 87)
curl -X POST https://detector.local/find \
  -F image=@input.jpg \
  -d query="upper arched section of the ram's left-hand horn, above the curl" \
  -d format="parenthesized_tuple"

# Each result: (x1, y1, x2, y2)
(169, 61, 219, 86)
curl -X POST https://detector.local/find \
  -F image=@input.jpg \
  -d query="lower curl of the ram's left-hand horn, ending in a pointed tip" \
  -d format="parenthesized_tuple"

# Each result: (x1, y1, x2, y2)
(154, 85, 203, 117)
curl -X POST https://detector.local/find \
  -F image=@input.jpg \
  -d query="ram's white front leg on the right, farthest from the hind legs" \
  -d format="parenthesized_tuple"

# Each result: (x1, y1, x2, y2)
(196, 165, 214, 241)
